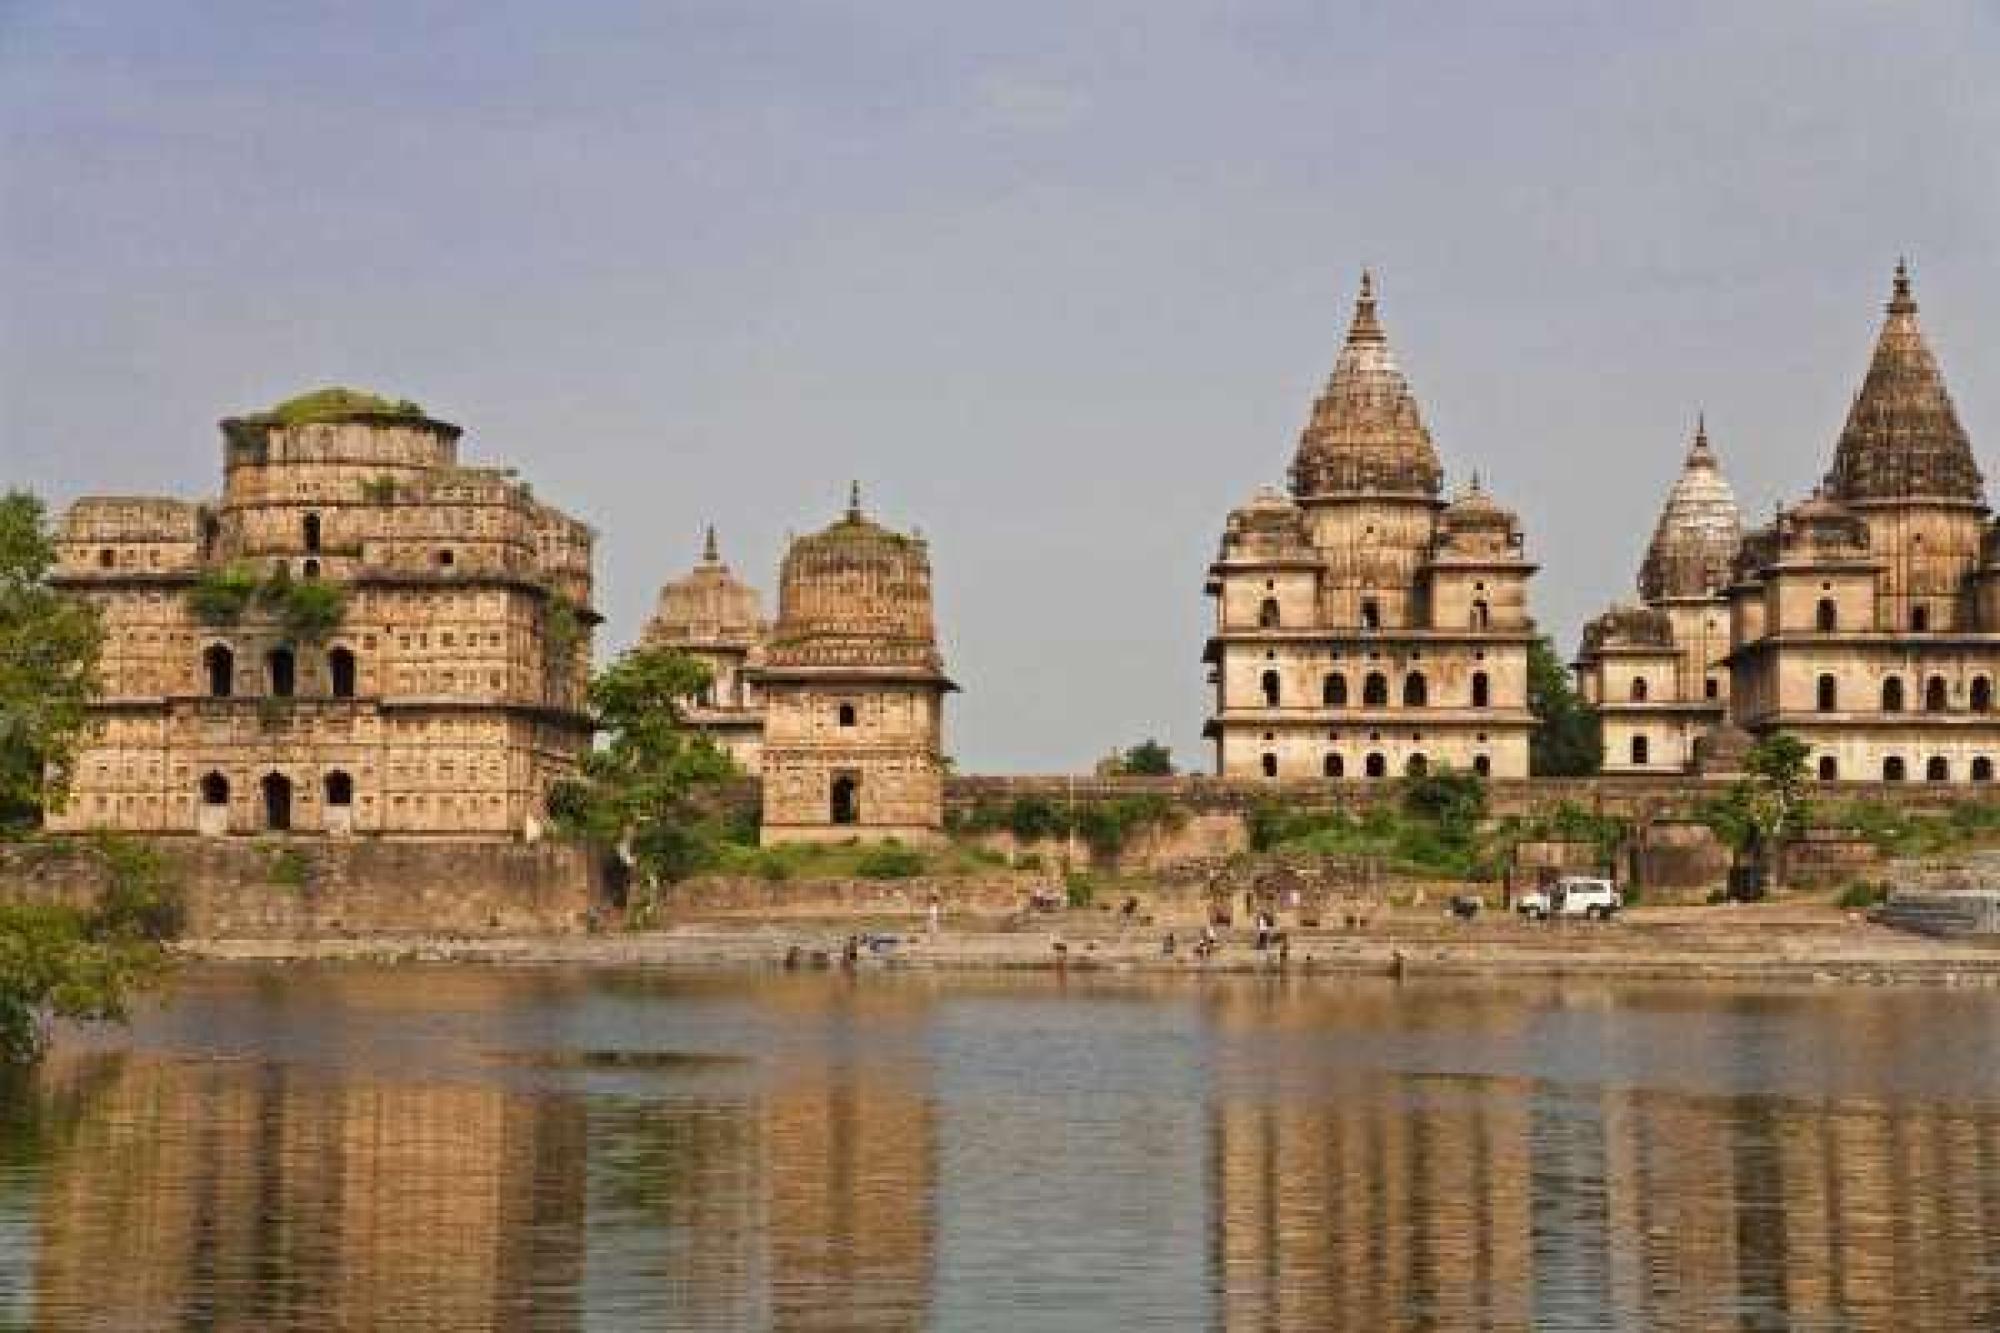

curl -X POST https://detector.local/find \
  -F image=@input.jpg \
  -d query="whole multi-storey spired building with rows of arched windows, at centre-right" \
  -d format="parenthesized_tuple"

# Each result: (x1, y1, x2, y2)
(1204, 274, 1536, 779)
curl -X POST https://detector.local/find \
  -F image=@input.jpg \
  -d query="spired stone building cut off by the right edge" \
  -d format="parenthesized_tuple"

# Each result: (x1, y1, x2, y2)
(1728, 264, 2000, 783)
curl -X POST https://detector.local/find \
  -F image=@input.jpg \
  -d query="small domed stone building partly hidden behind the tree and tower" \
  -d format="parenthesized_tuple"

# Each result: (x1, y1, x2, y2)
(640, 528, 770, 773)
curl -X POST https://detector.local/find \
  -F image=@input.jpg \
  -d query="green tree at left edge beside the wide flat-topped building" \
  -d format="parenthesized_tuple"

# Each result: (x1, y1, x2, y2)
(0, 490, 104, 831)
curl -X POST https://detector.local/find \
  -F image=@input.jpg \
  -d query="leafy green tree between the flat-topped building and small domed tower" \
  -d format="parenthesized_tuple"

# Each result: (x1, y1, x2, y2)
(548, 648, 736, 889)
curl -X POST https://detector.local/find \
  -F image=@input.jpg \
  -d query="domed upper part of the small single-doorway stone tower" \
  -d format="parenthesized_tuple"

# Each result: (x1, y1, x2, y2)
(766, 486, 942, 677)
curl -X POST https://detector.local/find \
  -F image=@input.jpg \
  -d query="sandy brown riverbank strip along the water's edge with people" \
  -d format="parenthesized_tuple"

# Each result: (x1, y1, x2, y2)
(168, 905, 2000, 987)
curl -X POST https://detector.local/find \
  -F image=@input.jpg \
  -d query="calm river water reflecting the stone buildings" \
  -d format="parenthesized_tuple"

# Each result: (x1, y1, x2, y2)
(0, 967, 2000, 1331)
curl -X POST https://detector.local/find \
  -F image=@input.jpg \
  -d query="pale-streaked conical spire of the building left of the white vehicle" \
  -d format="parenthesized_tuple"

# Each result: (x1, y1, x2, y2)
(1292, 270, 1444, 500)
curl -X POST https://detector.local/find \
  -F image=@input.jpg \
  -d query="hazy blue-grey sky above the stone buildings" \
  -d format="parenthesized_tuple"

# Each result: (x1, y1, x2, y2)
(0, 0, 2000, 773)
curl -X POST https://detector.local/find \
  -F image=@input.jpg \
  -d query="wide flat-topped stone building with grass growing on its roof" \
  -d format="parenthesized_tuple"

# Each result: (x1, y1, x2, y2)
(50, 390, 596, 839)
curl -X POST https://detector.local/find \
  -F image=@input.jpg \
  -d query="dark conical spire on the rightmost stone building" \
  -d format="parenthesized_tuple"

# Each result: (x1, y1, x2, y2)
(1826, 260, 1986, 508)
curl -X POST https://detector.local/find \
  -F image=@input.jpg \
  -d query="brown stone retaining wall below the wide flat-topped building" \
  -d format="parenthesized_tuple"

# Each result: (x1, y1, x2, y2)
(0, 839, 616, 939)
